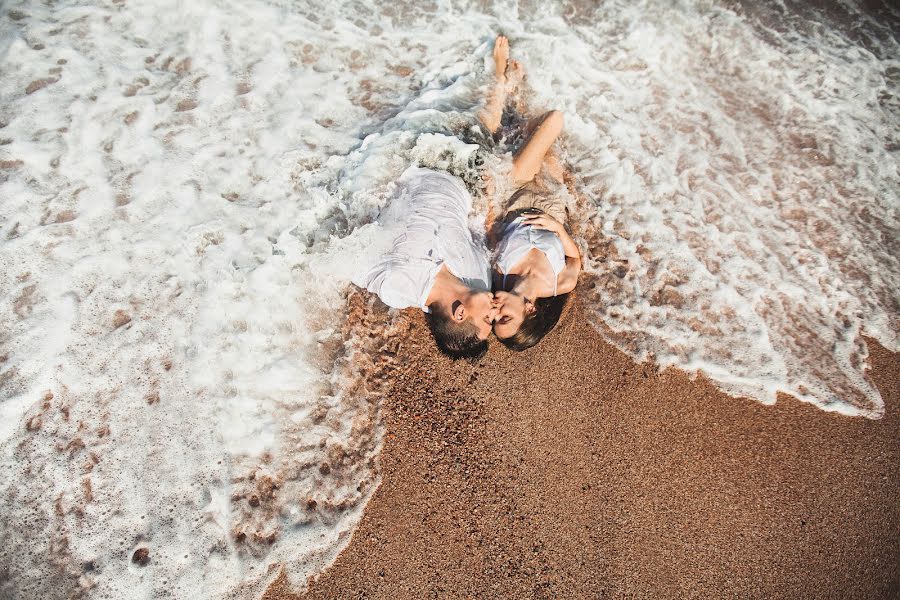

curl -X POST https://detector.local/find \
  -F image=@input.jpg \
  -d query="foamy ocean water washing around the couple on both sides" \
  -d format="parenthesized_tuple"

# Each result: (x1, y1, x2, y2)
(0, 0, 900, 598)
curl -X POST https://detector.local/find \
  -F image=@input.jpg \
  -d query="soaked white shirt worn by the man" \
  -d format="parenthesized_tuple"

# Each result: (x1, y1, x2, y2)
(354, 167, 491, 312)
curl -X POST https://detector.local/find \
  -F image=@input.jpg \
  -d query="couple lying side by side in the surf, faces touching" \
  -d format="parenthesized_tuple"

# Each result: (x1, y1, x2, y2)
(356, 36, 581, 357)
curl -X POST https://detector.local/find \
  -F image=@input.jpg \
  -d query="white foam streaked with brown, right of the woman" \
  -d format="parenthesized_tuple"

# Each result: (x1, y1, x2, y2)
(529, 3, 900, 417)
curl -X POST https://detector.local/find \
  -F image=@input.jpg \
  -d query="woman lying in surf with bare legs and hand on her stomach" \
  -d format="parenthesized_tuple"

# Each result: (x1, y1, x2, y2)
(479, 36, 581, 350)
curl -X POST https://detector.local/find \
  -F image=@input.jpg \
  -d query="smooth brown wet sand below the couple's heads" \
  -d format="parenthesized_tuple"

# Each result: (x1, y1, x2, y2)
(264, 299, 900, 600)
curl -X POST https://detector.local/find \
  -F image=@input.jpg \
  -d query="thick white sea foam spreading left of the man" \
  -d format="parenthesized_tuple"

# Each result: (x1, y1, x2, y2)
(0, 1, 500, 598)
